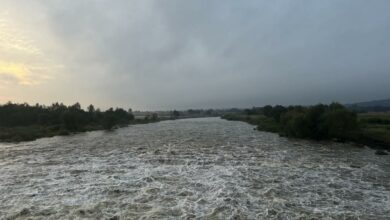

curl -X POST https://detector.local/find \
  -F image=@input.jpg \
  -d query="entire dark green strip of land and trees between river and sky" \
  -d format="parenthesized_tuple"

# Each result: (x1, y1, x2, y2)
(0, 102, 390, 150)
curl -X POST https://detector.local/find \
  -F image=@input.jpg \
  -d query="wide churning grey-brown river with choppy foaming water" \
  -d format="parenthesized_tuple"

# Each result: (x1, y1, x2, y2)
(0, 118, 390, 220)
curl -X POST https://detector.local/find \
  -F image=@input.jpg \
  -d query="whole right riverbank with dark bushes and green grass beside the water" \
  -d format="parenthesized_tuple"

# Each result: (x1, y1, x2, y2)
(221, 103, 390, 150)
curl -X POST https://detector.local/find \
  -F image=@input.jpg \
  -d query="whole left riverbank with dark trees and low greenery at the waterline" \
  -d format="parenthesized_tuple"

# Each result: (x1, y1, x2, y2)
(0, 102, 180, 142)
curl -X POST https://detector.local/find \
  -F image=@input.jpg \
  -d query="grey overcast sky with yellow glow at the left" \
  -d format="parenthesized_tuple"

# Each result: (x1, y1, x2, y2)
(0, 0, 390, 110)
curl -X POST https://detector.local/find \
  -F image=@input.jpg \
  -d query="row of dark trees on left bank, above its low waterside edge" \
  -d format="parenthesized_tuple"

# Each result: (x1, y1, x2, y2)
(0, 102, 134, 131)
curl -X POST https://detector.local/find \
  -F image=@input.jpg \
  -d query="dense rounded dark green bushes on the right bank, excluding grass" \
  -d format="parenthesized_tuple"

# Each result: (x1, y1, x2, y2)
(224, 103, 358, 140)
